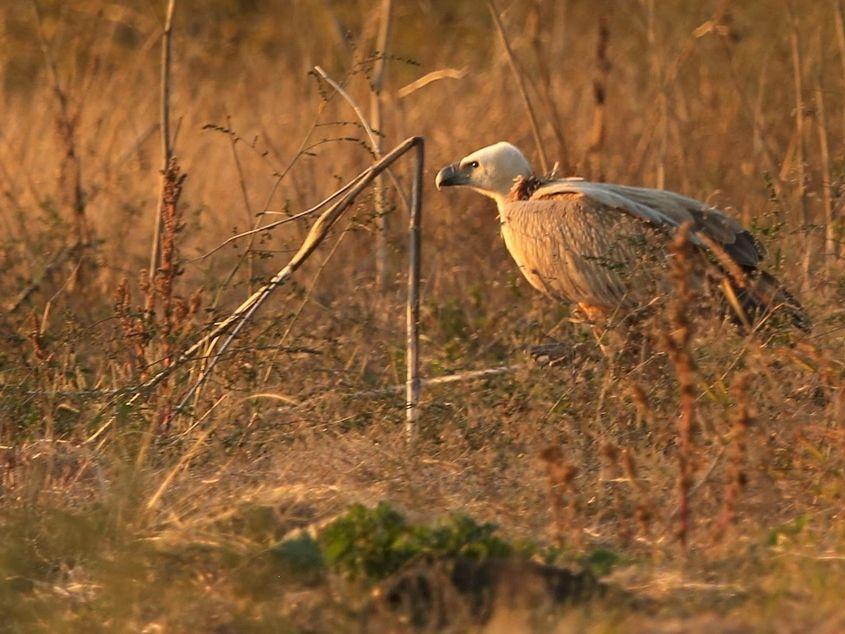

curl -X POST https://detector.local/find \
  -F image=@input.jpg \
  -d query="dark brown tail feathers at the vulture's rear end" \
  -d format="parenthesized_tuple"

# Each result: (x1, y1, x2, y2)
(728, 270, 812, 332)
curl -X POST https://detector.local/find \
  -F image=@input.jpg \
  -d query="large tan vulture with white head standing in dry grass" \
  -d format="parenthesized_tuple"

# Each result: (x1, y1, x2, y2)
(435, 142, 810, 340)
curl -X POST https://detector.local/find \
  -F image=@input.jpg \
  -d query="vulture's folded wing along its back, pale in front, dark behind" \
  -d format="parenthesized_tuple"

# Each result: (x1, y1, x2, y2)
(531, 179, 765, 269)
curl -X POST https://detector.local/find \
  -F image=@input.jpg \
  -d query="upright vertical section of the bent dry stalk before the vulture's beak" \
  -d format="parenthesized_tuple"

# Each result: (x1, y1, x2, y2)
(405, 138, 425, 442)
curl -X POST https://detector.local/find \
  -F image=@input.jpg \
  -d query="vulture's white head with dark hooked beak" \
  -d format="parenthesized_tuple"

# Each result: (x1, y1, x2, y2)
(434, 141, 533, 204)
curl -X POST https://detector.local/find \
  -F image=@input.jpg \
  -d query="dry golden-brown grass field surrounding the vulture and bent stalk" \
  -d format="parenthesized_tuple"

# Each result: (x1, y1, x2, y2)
(0, 0, 845, 633)
